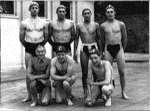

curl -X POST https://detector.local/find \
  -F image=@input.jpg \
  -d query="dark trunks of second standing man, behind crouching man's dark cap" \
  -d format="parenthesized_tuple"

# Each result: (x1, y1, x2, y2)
(53, 42, 71, 52)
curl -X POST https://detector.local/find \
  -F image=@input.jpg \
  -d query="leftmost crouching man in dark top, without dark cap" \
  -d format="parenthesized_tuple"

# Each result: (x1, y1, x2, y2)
(27, 45, 51, 107)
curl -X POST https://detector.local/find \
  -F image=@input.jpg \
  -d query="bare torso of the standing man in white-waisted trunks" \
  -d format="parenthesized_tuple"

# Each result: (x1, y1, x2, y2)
(78, 22, 98, 43)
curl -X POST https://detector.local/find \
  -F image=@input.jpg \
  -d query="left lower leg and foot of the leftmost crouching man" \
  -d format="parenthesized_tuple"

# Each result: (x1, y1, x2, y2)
(30, 80, 38, 107)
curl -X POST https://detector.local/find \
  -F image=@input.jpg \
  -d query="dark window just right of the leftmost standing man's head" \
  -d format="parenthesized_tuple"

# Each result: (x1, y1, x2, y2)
(36, 1, 46, 17)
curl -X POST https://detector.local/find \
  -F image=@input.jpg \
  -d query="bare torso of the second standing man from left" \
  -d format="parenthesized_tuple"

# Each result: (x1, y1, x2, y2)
(51, 19, 74, 43)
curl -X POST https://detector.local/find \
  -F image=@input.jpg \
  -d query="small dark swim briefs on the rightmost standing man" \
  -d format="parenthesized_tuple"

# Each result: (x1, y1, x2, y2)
(107, 44, 120, 58)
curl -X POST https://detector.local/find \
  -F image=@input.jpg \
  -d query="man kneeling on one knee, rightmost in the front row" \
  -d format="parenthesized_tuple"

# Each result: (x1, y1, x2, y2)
(85, 49, 113, 106)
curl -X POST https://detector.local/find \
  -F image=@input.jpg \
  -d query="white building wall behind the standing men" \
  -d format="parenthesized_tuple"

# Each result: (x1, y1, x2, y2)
(0, 0, 94, 71)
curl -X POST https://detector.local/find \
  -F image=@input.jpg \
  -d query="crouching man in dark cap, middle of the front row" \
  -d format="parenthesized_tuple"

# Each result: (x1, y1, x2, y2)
(51, 46, 76, 106)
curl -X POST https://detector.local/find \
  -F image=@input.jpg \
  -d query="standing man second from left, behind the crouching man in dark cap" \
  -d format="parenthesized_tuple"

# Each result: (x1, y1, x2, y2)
(48, 5, 75, 56)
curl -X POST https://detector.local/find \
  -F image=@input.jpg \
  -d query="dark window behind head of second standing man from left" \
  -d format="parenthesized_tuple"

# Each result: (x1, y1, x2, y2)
(60, 1, 72, 19)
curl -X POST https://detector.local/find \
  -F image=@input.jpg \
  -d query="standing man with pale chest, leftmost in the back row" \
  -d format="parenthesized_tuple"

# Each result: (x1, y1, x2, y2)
(20, 2, 48, 102)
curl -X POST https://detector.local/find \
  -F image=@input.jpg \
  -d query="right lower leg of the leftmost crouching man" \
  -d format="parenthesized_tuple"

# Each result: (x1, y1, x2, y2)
(41, 87, 51, 105)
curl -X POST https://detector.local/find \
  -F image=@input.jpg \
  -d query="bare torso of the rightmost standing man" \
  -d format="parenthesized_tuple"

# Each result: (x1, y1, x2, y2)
(101, 20, 122, 45)
